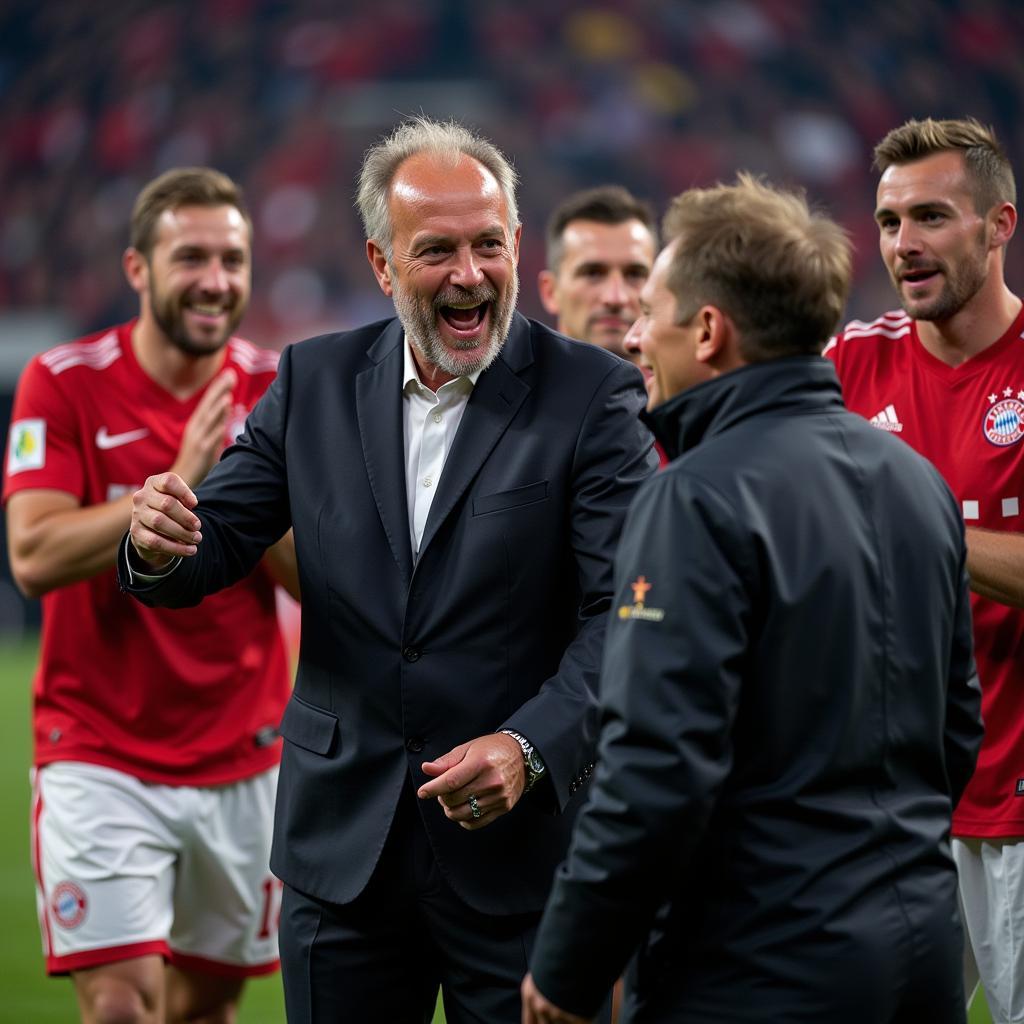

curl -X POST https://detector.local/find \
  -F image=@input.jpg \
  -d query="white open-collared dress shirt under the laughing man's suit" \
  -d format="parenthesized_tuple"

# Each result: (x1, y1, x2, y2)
(401, 338, 480, 560)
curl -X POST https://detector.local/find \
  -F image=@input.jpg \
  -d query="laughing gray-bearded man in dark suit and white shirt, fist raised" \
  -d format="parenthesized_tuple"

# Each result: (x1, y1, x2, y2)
(120, 119, 654, 1024)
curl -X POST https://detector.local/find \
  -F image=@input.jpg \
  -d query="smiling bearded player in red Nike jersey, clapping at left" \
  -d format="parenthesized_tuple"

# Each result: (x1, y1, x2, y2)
(4, 168, 296, 1024)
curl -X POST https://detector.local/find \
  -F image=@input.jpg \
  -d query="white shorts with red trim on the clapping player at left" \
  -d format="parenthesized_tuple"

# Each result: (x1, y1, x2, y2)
(32, 761, 282, 977)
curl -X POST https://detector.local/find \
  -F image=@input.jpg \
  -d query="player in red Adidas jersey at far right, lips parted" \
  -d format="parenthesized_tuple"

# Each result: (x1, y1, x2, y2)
(825, 119, 1024, 1024)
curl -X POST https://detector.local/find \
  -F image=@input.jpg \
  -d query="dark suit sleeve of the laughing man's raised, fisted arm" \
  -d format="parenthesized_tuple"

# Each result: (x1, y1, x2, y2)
(118, 349, 292, 608)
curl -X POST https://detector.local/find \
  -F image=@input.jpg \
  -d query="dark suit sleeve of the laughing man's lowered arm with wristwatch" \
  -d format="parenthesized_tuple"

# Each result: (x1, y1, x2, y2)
(505, 360, 657, 809)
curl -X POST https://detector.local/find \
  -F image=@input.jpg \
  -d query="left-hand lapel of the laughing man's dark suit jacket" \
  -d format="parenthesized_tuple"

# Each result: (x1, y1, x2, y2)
(355, 321, 413, 585)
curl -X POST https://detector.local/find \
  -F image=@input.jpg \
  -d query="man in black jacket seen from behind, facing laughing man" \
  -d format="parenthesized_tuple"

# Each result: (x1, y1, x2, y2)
(523, 176, 982, 1024)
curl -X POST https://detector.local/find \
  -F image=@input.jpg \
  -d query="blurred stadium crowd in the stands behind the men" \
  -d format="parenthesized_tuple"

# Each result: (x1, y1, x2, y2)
(0, 0, 1024, 614)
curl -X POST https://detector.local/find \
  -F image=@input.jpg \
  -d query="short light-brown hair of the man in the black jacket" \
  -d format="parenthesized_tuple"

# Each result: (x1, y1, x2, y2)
(664, 173, 852, 362)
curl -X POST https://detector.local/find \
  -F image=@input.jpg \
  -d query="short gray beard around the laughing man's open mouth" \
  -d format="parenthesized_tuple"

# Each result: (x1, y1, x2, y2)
(391, 268, 519, 377)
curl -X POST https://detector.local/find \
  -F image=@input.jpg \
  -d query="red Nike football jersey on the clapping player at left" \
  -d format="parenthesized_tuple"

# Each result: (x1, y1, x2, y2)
(3, 324, 291, 785)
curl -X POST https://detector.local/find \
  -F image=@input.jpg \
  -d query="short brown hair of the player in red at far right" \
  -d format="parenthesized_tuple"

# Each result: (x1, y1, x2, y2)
(874, 118, 1017, 215)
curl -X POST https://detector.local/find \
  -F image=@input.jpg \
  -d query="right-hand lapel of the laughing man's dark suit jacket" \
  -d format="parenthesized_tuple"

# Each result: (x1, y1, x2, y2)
(420, 313, 532, 559)
